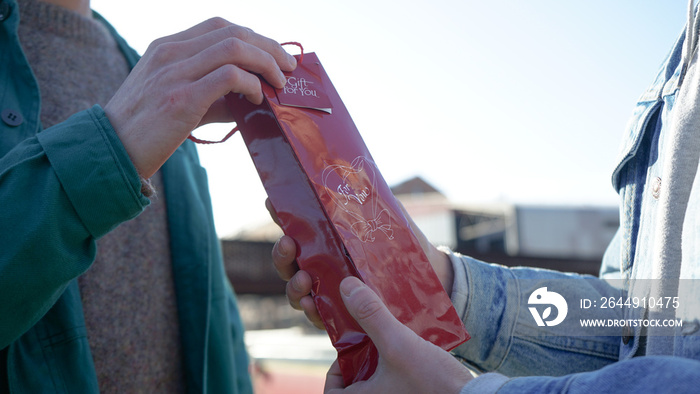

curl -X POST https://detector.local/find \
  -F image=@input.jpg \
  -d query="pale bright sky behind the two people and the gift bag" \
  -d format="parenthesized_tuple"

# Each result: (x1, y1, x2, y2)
(93, 0, 687, 236)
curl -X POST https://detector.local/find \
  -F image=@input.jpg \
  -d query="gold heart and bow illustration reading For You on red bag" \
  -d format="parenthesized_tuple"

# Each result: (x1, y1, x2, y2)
(322, 156, 394, 242)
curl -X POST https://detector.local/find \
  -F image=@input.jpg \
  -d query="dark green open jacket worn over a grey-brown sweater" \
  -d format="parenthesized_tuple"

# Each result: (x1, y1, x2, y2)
(0, 0, 252, 393)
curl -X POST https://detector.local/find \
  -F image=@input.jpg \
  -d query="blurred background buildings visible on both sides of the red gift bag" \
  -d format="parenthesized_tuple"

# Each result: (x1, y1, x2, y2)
(222, 177, 619, 294)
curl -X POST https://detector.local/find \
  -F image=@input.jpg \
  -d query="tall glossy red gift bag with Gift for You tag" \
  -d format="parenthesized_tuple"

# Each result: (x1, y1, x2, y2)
(227, 53, 469, 384)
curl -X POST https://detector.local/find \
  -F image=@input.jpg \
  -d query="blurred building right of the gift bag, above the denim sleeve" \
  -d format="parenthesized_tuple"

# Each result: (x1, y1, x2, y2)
(392, 178, 619, 275)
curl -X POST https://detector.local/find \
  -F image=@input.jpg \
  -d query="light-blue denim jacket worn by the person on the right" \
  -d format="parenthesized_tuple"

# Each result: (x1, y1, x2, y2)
(450, 3, 700, 393)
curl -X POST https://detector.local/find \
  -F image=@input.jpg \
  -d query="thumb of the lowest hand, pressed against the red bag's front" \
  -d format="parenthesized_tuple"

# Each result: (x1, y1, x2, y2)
(340, 276, 413, 353)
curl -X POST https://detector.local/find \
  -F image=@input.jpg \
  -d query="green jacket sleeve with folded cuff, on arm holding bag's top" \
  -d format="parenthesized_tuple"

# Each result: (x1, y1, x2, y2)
(0, 106, 149, 349)
